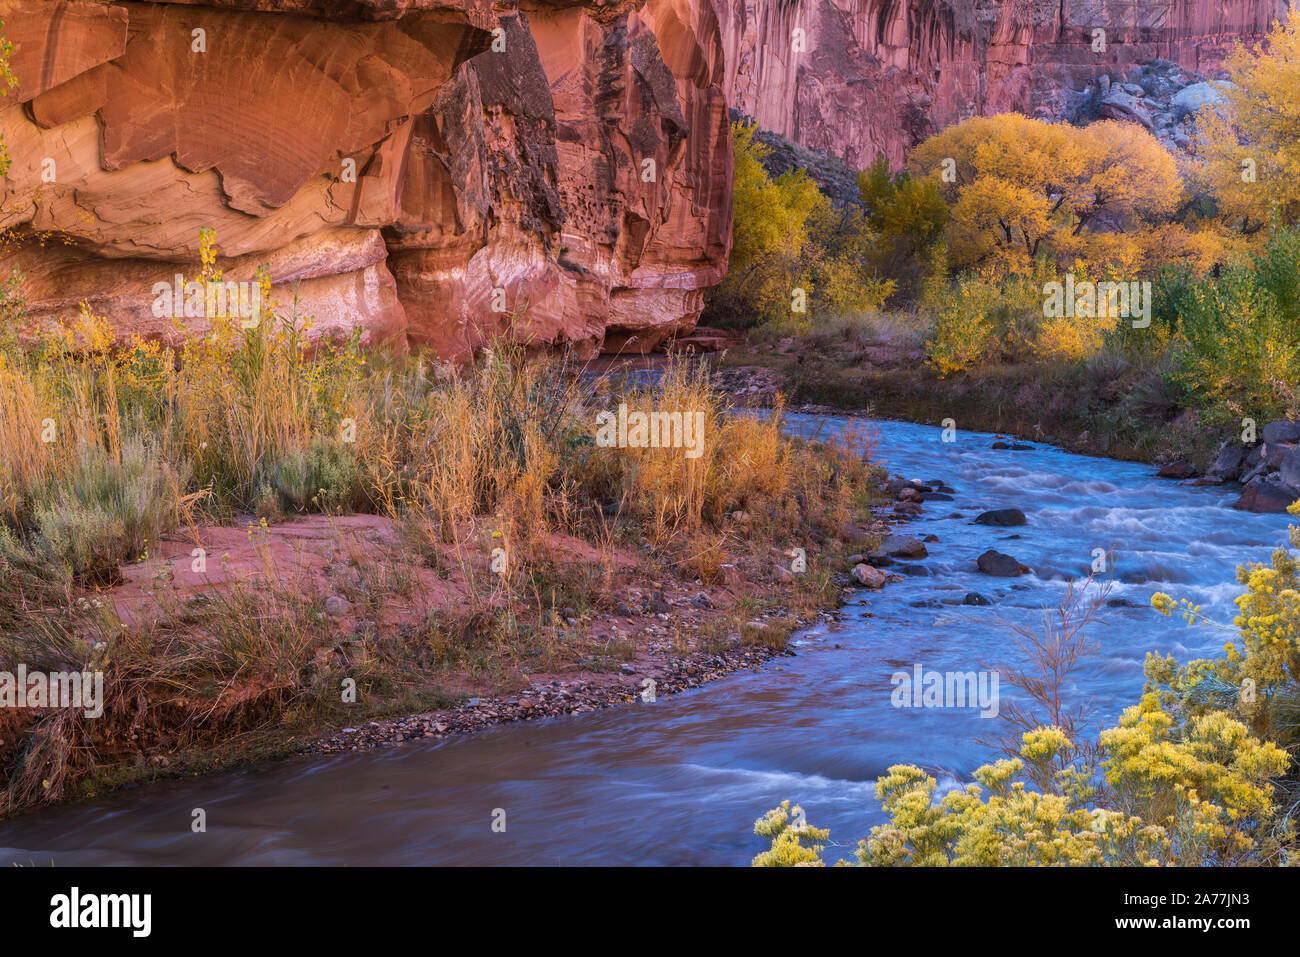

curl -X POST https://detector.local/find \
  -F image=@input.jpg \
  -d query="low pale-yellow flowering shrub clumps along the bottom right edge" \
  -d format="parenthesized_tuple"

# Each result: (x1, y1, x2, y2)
(754, 717, 1290, 866)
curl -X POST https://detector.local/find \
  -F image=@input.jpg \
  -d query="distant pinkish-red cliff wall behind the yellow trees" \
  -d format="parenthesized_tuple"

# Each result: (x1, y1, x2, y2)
(714, 0, 1286, 168)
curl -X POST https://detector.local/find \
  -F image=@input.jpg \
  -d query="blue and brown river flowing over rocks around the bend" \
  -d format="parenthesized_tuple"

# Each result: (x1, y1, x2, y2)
(0, 416, 1288, 865)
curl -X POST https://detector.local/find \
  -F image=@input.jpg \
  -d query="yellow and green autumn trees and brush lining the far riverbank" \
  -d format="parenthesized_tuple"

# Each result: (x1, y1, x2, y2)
(706, 12, 1300, 465)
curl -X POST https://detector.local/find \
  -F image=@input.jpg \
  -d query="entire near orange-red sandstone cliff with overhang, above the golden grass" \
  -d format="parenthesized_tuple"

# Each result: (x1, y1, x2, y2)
(0, 0, 731, 356)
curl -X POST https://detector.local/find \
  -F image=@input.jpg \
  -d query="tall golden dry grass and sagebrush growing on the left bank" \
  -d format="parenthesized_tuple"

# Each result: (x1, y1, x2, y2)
(0, 239, 874, 806)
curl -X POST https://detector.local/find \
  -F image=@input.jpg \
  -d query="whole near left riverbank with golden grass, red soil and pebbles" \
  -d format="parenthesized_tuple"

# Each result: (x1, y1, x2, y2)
(0, 235, 878, 810)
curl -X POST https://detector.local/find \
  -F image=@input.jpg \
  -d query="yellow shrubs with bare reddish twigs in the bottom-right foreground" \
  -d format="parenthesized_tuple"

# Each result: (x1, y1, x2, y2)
(754, 522, 1300, 866)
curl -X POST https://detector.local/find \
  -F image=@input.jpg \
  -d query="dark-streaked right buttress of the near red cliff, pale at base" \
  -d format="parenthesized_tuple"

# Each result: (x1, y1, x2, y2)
(389, 0, 731, 351)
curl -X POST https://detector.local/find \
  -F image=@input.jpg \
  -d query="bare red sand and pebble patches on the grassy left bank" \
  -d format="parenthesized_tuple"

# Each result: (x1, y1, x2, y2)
(101, 515, 832, 763)
